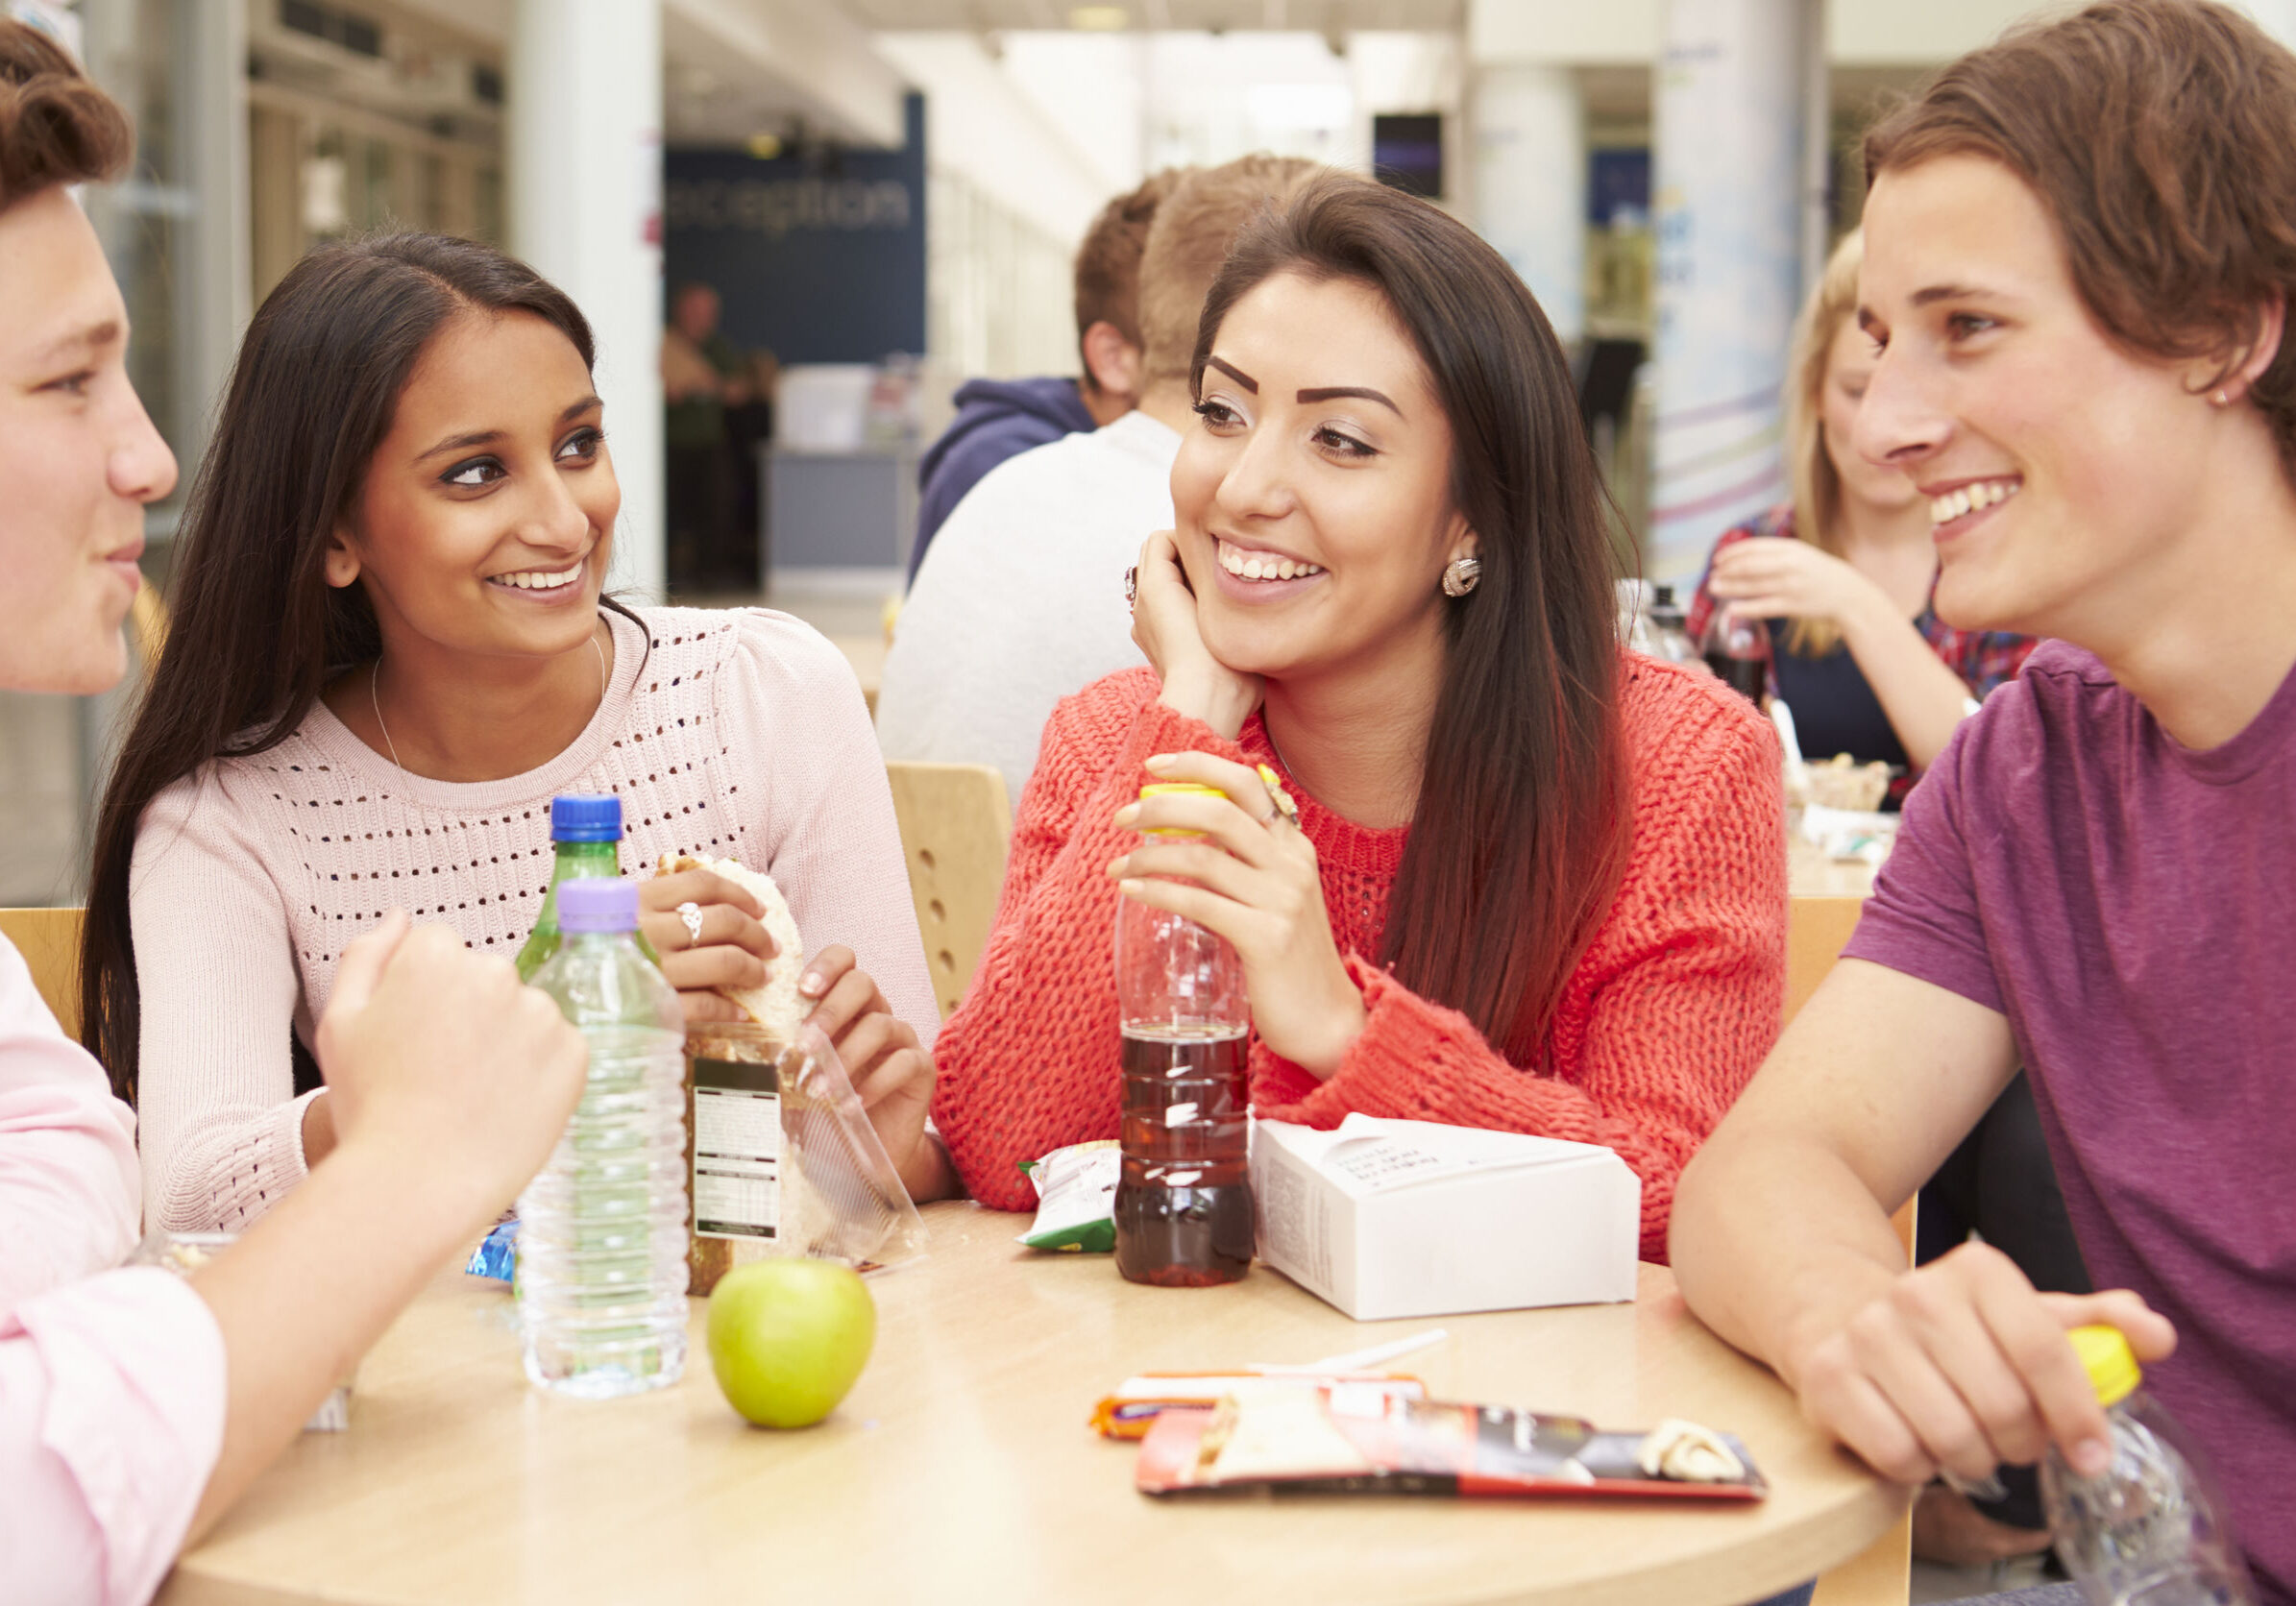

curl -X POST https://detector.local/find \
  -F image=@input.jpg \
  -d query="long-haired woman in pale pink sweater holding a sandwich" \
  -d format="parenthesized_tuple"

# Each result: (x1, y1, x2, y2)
(83, 234, 948, 1228)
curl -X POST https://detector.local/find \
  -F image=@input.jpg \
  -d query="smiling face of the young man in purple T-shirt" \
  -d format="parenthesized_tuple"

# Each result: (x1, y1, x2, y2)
(1855, 156, 2218, 645)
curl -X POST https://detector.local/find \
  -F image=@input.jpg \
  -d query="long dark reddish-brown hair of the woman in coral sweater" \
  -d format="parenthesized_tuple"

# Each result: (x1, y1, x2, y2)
(1189, 175, 1630, 1067)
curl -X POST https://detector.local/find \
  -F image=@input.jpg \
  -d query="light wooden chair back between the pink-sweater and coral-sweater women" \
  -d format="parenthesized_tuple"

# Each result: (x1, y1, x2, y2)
(884, 762, 1013, 1021)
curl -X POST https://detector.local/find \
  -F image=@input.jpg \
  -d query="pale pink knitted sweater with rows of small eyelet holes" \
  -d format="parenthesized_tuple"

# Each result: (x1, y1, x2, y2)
(129, 608, 940, 1232)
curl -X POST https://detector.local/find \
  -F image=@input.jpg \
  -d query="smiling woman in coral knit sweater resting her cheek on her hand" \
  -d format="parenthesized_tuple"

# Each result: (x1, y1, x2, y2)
(935, 175, 1786, 1259)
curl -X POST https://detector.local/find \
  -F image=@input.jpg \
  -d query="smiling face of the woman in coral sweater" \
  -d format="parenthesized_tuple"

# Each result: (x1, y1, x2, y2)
(1171, 273, 1477, 681)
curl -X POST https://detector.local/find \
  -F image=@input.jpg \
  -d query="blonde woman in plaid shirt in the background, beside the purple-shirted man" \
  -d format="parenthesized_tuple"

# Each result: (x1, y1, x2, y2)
(1690, 234, 2035, 801)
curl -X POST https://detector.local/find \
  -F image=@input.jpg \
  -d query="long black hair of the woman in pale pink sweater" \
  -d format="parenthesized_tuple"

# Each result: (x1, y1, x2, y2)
(81, 234, 643, 1102)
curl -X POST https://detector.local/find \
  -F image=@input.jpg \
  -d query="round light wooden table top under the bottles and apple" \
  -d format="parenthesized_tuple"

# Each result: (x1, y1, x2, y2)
(159, 1203, 1903, 1606)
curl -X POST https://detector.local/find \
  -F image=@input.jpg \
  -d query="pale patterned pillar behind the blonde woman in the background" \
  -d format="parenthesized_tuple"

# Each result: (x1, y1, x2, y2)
(1644, 0, 1820, 580)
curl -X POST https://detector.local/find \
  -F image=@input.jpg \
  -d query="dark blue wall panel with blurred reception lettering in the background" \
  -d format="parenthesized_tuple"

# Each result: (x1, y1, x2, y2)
(664, 94, 925, 362)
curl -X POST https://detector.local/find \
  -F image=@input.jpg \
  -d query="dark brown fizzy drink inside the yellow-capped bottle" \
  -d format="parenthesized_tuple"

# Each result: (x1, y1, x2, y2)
(1116, 1030, 1252, 1287)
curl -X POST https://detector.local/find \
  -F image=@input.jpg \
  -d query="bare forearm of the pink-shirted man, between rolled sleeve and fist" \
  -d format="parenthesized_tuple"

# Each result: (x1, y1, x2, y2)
(186, 1145, 499, 1545)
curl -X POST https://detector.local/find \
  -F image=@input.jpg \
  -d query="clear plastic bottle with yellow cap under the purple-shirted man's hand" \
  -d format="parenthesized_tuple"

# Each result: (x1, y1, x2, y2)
(2041, 1326, 2257, 1606)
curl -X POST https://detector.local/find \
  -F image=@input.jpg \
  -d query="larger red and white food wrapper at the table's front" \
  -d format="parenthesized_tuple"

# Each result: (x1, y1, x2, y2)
(1132, 1381, 1768, 1500)
